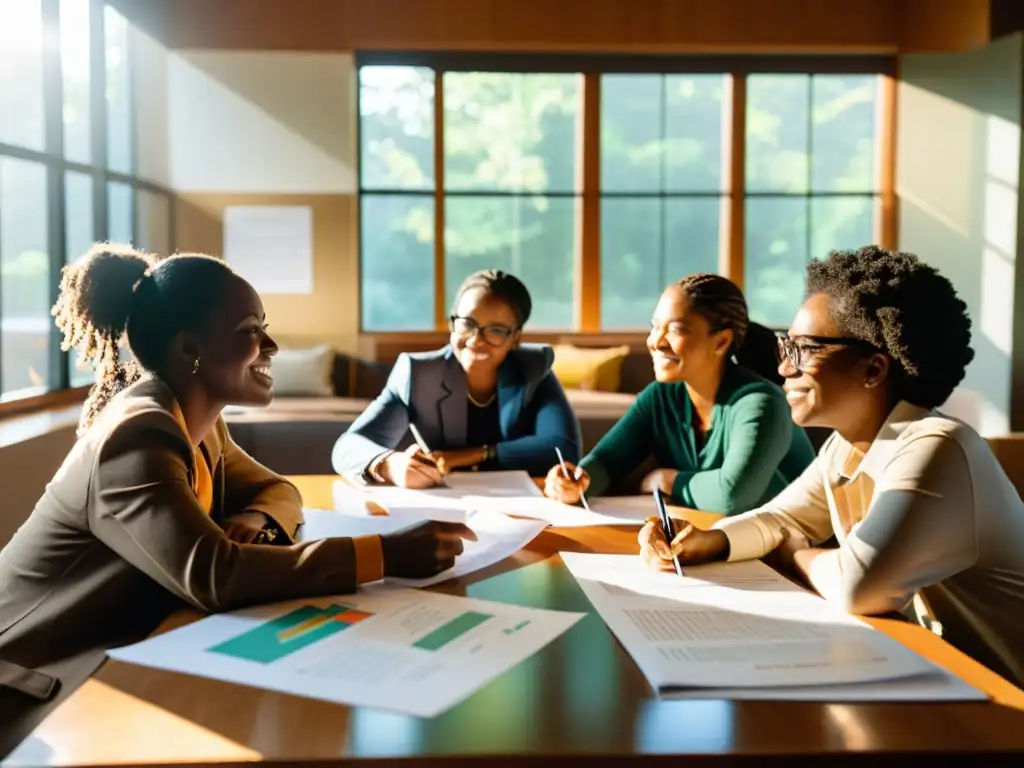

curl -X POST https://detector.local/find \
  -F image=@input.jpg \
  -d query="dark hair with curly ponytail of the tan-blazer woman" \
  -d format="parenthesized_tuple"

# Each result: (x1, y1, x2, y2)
(56, 243, 234, 435)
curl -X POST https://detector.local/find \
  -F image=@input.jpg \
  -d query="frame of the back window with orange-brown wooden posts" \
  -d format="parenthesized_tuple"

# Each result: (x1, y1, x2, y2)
(355, 50, 897, 338)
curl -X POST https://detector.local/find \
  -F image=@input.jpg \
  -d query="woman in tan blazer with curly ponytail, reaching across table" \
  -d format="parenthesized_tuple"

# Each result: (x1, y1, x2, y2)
(0, 244, 471, 754)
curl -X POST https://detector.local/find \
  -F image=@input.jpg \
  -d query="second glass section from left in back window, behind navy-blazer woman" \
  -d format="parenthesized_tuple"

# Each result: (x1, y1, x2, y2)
(443, 72, 583, 329)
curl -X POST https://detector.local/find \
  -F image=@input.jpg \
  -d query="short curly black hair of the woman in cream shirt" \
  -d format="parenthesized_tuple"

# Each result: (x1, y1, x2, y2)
(807, 246, 974, 408)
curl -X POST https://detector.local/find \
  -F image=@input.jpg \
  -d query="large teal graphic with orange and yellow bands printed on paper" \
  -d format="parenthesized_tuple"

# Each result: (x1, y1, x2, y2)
(207, 604, 373, 664)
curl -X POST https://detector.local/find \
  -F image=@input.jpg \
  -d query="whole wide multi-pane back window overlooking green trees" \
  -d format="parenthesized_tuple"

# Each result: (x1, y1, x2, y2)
(359, 54, 895, 332)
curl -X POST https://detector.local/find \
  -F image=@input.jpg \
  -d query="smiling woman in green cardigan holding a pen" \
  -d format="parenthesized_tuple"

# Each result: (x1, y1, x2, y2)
(544, 274, 814, 515)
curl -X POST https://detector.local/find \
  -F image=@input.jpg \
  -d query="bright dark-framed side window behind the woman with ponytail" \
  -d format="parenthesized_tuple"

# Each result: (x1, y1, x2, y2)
(0, 0, 172, 401)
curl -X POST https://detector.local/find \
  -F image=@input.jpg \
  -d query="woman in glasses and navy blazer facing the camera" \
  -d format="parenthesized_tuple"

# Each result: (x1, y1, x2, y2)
(332, 269, 581, 488)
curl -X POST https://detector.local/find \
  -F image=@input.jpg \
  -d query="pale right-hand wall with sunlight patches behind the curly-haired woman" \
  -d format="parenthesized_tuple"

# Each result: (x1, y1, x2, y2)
(897, 35, 1022, 435)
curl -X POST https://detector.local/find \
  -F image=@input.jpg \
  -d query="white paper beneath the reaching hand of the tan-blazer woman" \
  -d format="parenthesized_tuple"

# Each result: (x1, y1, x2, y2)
(298, 509, 548, 587)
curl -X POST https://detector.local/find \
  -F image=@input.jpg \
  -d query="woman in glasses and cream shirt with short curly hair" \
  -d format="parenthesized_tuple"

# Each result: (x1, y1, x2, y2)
(640, 246, 1024, 684)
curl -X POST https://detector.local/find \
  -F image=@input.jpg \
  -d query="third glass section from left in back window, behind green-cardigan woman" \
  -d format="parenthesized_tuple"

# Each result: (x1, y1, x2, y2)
(601, 75, 728, 330)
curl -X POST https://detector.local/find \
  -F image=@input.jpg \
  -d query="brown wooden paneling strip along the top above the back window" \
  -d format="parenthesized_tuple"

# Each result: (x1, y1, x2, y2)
(121, 0, 905, 53)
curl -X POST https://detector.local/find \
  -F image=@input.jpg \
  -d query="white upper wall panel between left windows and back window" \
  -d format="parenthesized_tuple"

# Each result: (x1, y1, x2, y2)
(169, 51, 356, 194)
